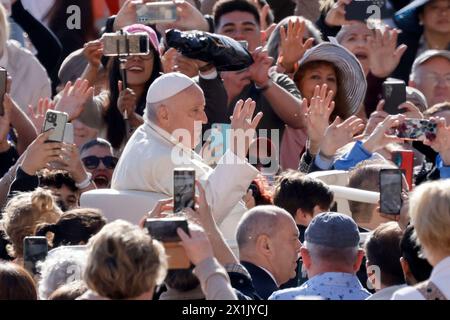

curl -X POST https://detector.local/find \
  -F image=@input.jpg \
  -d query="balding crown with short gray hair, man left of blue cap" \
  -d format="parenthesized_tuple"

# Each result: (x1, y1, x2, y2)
(236, 205, 292, 250)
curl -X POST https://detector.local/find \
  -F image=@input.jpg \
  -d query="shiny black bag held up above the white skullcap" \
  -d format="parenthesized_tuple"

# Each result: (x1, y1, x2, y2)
(166, 29, 254, 71)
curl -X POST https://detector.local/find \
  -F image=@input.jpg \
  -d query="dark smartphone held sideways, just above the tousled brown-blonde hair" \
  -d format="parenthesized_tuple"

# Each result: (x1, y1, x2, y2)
(144, 217, 189, 242)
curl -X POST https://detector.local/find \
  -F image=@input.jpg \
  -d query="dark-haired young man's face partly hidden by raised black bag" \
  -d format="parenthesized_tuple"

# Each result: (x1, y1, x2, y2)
(216, 11, 262, 51)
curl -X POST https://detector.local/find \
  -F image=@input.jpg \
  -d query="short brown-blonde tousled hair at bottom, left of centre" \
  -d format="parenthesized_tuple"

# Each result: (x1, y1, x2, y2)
(84, 220, 167, 299)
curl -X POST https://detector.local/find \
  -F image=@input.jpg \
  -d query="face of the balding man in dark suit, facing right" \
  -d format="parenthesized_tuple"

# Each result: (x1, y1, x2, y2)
(270, 216, 301, 285)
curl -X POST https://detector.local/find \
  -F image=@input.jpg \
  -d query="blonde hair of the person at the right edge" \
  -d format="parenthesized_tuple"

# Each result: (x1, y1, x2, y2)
(409, 180, 450, 255)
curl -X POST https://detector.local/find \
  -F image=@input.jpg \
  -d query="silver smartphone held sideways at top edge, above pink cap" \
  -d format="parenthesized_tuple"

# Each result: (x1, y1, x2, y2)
(136, 1, 178, 25)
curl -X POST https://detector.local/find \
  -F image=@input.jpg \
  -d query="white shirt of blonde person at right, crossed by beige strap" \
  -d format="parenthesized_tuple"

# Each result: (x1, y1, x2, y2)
(392, 257, 450, 300)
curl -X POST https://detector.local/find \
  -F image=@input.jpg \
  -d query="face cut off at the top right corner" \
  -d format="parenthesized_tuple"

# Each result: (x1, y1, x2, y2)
(420, 0, 450, 33)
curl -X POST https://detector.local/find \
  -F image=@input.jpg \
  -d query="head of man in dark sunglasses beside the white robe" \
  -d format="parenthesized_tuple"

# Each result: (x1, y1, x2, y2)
(80, 138, 118, 189)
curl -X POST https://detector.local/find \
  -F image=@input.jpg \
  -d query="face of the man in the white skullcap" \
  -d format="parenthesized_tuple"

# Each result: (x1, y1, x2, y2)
(163, 85, 208, 149)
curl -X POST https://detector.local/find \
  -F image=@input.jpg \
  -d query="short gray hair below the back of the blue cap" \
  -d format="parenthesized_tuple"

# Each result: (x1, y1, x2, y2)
(303, 241, 359, 266)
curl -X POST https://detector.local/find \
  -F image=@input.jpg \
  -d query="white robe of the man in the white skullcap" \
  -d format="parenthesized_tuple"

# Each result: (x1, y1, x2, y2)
(111, 123, 258, 240)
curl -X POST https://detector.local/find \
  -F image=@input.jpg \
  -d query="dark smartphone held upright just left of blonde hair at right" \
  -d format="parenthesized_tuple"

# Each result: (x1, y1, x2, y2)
(380, 169, 402, 215)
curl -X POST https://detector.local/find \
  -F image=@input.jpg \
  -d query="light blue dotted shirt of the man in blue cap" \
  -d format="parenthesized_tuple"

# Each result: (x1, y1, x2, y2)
(269, 272, 370, 300)
